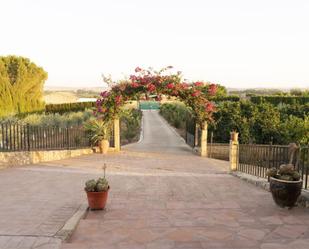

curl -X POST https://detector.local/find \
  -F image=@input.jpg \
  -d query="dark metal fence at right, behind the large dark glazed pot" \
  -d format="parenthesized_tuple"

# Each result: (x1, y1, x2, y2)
(237, 144, 309, 189)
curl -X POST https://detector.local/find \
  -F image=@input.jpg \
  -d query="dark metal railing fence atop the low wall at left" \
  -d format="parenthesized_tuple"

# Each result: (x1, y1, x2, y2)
(0, 123, 90, 151)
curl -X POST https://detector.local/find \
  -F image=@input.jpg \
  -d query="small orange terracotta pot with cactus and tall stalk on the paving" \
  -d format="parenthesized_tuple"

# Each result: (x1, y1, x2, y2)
(85, 165, 110, 210)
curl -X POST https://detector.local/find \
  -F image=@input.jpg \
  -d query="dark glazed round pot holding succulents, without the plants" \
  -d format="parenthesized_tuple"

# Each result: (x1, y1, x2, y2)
(270, 177, 302, 208)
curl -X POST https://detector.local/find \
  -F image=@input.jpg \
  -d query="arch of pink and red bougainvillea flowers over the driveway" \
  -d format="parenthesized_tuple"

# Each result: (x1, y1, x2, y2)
(95, 66, 218, 126)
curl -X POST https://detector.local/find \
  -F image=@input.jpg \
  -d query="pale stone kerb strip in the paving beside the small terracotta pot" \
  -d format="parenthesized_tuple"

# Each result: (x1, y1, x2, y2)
(54, 204, 88, 241)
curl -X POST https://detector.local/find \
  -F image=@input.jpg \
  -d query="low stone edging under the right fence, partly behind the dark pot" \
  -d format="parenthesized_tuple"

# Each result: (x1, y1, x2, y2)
(230, 171, 309, 208)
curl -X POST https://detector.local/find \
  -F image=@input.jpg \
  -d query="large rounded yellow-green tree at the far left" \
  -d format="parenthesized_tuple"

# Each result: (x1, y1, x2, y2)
(0, 56, 47, 116)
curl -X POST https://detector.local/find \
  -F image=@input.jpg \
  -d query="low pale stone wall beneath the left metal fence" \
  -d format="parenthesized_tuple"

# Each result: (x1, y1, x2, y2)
(0, 148, 94, 169)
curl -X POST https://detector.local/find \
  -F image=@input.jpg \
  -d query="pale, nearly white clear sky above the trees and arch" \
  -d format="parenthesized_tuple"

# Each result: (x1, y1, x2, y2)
(0, 0, 309, 88)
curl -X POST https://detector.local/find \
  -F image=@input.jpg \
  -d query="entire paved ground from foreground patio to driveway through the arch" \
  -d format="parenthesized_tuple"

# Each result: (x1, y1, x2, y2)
(0, 111, 309, 249)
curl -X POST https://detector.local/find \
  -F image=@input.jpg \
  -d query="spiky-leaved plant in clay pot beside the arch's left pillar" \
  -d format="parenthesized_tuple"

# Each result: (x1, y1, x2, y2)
(85, 119, 110, 154)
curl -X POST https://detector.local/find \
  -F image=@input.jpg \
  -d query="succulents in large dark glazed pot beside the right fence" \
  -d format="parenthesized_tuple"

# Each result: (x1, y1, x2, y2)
(267, 164, 302, 208)
